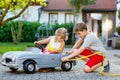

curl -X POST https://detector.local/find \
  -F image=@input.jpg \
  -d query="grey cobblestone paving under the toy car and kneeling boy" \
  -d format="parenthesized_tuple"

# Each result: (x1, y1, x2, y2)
(0, 48, 120, 80)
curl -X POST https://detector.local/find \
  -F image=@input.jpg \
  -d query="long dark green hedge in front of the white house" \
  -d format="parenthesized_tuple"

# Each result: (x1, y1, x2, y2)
(0, 20, 74, 44)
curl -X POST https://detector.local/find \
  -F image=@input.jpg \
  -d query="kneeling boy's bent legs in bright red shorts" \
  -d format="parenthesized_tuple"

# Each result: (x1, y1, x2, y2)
(82, 49, 104, 72)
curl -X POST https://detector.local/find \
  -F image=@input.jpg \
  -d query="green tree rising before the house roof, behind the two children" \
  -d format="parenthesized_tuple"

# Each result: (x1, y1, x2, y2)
(68, 0, 95, 44)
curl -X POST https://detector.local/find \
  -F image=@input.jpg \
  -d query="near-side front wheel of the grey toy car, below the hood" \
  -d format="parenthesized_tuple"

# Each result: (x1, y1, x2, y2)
(23, 61, 36, 74)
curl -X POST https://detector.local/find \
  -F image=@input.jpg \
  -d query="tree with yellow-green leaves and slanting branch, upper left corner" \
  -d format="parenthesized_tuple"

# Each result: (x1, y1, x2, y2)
(0, 0, 47, 27)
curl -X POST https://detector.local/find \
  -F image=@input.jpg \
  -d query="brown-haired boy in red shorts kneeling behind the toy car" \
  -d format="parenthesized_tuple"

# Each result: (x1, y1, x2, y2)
(61, 23, 110, 73)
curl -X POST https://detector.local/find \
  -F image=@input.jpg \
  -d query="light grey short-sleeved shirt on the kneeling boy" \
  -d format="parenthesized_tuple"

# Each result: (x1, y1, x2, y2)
(81, 33, 105, 52)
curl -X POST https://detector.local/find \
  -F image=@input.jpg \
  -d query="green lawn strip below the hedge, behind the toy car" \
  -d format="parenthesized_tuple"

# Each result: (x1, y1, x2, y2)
(0, 42, 72, 54)
